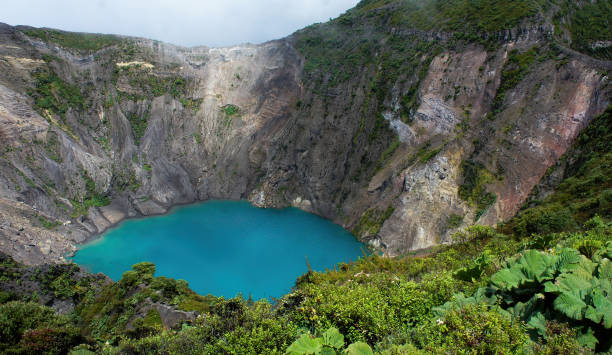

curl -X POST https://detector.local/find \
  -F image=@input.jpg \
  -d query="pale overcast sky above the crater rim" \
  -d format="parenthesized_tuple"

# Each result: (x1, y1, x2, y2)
(0, 0, 359, 46)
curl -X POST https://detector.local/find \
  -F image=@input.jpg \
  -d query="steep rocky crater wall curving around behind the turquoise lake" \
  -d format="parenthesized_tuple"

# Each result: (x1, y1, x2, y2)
(0, 1, 610, 263)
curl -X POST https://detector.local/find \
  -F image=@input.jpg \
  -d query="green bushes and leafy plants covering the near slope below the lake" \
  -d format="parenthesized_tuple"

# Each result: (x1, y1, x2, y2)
(0, 217, 612, 354)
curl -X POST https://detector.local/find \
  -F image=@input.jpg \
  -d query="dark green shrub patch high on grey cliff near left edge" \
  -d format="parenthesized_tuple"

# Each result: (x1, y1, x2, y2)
(27, 66, 85, 119)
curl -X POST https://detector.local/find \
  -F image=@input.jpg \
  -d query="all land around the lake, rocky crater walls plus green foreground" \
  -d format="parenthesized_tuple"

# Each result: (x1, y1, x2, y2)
(0, 0, 612, 354)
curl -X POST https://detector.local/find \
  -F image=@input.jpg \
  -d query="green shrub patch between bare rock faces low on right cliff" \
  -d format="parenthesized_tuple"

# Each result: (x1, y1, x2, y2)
(459, 160, 497, 220)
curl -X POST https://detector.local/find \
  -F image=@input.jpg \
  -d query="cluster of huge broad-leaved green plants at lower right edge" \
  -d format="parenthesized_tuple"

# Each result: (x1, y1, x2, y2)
(436, 242, 612, 349)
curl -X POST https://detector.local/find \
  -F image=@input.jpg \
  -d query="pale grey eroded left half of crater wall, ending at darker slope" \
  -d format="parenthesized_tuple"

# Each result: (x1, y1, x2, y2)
(0, 26, 300, 263)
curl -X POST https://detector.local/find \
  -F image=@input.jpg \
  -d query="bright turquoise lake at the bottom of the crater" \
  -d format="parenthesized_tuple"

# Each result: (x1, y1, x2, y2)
(72, 201, 365, 299)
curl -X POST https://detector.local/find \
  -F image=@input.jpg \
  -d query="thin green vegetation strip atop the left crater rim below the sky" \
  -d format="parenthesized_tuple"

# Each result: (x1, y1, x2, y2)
(22, 28, 121, 52)
